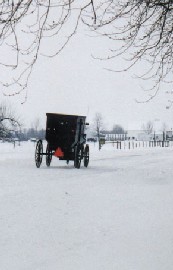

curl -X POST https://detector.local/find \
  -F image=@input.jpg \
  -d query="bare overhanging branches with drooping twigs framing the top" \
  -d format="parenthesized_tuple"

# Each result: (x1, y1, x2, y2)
(0, 0, 173, 99)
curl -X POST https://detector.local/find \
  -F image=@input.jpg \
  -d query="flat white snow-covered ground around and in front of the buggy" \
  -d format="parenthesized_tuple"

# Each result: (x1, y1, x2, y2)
(0, 143, 173, 270)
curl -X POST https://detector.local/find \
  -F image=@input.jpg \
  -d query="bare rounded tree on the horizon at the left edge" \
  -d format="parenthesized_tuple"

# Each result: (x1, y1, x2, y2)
(0, 104, 21, 139)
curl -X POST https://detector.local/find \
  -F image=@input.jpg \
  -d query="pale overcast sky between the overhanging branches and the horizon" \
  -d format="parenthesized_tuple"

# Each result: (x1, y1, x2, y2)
(1, 26, 173, 132)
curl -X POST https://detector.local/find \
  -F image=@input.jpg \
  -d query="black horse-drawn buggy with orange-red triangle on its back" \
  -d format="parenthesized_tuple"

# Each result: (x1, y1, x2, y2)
(35, 113, 89, 169)
